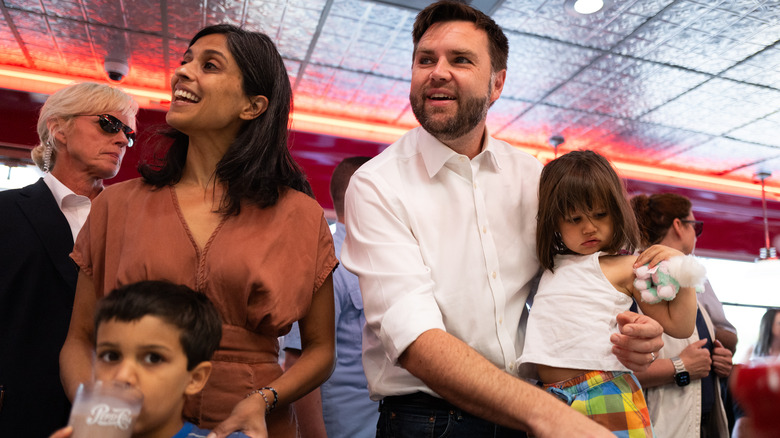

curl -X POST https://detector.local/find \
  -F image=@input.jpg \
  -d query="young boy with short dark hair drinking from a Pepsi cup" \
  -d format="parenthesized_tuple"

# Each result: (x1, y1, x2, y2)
(52, 281, 246, 438)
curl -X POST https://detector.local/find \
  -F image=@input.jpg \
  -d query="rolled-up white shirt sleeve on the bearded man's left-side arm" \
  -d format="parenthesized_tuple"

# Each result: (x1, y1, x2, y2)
(342, 171, 445, 363)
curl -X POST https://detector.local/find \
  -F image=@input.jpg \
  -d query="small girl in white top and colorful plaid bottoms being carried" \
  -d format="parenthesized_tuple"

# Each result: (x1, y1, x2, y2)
(518, 151, 696, 437)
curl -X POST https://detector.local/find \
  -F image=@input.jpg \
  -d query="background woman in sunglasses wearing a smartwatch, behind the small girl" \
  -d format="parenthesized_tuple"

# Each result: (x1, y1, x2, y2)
(631, 193, 737, 438)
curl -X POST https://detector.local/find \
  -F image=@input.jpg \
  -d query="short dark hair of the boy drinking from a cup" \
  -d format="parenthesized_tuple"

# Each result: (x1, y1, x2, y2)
(95, 281, 222, 371)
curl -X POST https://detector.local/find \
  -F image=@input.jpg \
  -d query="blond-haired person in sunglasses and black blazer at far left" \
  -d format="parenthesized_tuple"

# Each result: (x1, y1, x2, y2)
(0, 82, 138, 438)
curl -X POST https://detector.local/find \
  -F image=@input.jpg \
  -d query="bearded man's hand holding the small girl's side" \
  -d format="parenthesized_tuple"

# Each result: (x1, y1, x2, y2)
(609, 311, 664, 371)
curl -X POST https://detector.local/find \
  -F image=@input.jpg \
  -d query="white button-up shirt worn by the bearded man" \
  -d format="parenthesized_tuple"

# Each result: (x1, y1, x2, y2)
(341, 128, 542, 400)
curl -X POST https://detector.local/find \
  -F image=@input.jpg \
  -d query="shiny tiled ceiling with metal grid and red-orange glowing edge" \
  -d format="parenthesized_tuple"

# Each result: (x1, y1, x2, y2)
(0, 0, 780, 186)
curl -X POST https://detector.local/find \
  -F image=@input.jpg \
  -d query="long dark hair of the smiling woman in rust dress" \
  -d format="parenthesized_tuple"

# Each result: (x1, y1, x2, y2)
(138, 24, 313, 214)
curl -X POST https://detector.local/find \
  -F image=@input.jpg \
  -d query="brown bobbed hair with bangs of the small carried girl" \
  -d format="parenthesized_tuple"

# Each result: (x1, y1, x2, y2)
(536, 151, 639, 271)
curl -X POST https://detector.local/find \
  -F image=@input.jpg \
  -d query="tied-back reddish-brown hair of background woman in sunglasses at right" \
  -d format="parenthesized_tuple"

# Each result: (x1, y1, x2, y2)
(631, 193, 691, 247)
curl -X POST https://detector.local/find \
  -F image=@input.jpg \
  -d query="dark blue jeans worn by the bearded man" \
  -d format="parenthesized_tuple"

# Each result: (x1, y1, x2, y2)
(376, 393, 526, 438)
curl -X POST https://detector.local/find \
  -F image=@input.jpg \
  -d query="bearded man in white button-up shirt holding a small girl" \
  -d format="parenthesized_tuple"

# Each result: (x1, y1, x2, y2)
(341, 3, 661, 437)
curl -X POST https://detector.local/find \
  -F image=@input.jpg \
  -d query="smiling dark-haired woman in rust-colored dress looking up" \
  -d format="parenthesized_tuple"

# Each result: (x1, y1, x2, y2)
(60, 25, 338, 437)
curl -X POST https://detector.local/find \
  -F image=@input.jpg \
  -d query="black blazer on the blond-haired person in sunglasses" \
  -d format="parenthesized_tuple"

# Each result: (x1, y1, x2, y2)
(0, 179, 78, 438)
